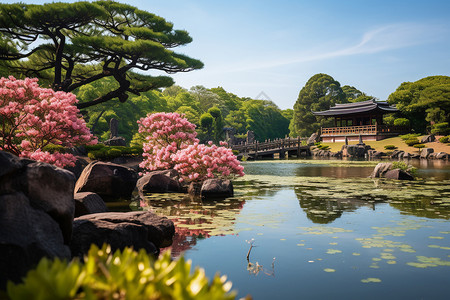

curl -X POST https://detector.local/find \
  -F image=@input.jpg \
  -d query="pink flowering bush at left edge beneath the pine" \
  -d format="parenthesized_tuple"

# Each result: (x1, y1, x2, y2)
(0, 76, 97, 167)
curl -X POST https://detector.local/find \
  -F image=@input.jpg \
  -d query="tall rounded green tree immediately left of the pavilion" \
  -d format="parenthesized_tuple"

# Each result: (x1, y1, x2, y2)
(289, 73, 348, 137)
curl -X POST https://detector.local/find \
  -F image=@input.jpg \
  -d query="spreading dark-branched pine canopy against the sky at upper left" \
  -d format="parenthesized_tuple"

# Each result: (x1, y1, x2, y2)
(0, 1, 203, 108)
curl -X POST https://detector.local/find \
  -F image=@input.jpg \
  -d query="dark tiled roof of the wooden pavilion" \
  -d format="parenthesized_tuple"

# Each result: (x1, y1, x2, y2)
(312, 100, 398, 116)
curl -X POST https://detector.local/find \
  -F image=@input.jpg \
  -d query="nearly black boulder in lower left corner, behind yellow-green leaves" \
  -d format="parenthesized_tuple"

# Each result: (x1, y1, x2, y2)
(0, 192, 71, 289)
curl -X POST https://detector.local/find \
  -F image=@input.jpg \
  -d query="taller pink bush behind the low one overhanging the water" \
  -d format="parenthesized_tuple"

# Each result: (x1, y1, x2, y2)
(138, 113, 198, 171)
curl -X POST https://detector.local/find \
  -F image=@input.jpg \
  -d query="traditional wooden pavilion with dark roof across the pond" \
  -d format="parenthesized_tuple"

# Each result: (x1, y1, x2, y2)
(313, 100, 409, 142)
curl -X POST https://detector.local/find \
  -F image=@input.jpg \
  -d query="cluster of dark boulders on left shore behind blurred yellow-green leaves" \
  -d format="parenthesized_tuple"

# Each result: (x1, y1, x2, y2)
(0, 151, 175, 290)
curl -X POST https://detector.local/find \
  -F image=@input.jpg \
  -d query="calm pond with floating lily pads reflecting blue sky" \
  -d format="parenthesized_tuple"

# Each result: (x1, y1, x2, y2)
(135, 160, 450, 299)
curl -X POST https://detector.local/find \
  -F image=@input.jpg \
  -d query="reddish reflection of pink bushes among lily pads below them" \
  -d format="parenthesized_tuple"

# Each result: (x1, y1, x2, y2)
(140, 193, 245, 256)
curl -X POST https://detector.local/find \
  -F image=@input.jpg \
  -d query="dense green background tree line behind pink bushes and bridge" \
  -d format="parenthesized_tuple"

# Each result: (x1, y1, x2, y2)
(76, 79, 292, 142)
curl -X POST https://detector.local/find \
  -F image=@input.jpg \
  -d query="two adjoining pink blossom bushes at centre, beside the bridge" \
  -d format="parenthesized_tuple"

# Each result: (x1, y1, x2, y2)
(138, 113, 244, 182)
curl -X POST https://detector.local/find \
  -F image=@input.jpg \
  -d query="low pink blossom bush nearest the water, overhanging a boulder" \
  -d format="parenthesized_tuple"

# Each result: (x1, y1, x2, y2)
(173, 143, 244, 182)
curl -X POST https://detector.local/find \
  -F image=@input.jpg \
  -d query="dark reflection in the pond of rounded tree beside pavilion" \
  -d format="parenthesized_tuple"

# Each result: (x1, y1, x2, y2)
(294, 187, 375, 224)
